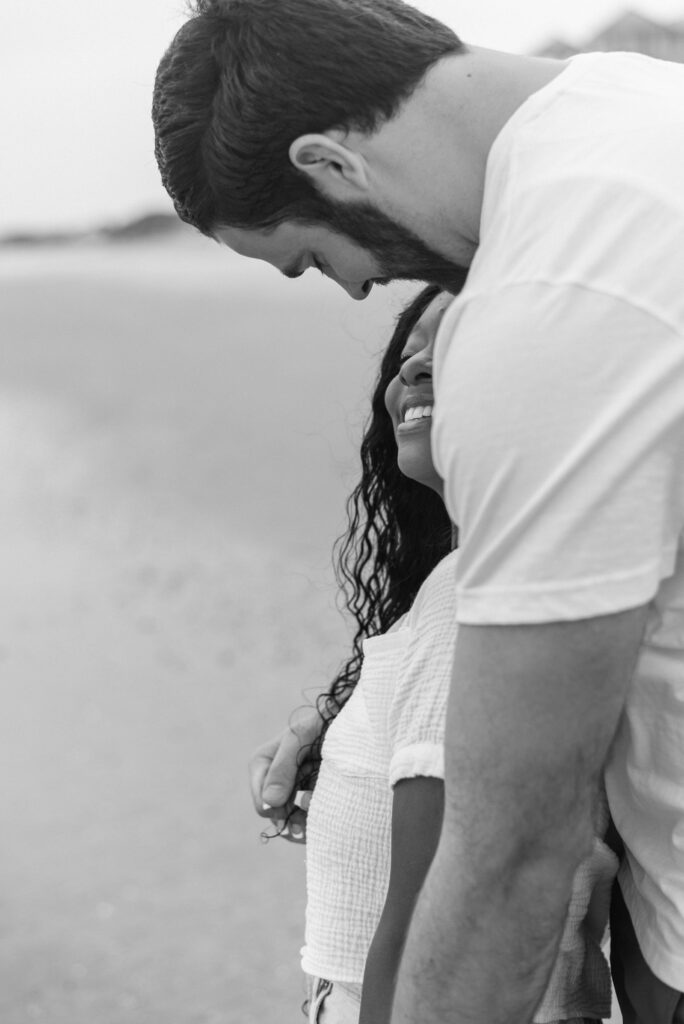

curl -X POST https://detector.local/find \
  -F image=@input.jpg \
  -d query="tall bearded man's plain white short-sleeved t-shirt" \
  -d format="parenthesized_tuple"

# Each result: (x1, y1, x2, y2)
(432, 53, 684, 989)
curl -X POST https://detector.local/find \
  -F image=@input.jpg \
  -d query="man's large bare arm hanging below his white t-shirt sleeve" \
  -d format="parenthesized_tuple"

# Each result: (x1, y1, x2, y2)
(391, 608, 646, 1024)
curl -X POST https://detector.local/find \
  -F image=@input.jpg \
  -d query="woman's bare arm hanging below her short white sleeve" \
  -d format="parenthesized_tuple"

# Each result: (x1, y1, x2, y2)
(359, 777, 444, 1024)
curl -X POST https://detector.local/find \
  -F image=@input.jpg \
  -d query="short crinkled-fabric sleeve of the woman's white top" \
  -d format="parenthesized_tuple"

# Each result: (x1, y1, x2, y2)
(388, 555, 457, 786)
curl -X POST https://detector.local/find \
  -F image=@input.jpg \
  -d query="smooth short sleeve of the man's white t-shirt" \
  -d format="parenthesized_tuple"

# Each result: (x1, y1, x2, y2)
(433, 284, 684, 625)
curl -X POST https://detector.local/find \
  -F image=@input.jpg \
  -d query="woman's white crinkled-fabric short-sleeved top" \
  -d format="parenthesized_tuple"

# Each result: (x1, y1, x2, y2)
(302, 552, 616, 1021)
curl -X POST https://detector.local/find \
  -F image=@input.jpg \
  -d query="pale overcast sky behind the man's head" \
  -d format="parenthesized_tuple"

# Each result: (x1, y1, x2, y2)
(5, 0, 684, 233)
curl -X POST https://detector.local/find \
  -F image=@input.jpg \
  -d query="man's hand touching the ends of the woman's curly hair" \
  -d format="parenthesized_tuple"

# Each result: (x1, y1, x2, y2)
(249, 708, 323, 843)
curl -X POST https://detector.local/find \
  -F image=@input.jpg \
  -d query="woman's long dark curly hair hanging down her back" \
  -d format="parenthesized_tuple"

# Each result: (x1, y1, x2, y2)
(293, 285, 453, 795)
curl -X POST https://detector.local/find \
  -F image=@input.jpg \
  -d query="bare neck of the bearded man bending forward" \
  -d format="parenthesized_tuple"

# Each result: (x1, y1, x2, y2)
(358, 48, 565, 265)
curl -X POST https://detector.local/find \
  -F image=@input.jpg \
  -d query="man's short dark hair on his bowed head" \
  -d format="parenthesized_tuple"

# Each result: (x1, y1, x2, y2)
(153, 0, 464, 234)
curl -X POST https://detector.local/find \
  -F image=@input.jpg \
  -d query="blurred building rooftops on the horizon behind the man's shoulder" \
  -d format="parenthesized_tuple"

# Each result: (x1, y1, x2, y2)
(537, 5, 684, 63)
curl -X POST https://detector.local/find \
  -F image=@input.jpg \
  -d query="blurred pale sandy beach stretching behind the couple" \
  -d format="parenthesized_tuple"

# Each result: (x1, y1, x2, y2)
(0, 238, 618, 1024)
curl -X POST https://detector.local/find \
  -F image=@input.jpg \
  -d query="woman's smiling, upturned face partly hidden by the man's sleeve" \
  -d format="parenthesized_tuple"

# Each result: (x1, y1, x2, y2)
(385, 292, 454, 496)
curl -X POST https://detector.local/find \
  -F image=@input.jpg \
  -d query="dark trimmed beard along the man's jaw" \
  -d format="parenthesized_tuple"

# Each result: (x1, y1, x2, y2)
(326, 200, 468, 295)
